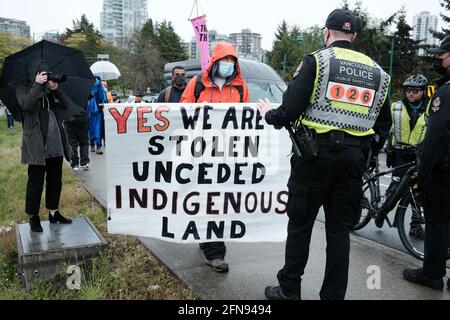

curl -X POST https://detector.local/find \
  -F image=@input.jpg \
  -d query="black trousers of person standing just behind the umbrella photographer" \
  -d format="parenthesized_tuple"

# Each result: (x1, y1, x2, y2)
(66, 118, 89, 168)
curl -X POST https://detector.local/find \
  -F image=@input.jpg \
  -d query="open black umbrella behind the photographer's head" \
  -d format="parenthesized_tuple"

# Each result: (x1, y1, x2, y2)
(0, 40, 95, 121)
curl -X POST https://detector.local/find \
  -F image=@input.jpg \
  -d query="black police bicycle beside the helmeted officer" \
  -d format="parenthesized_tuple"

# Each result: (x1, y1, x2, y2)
(353, 144, 425, 259)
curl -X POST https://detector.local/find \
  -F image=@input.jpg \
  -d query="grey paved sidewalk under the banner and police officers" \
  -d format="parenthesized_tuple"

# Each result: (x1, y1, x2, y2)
(78, 154, 450, 300)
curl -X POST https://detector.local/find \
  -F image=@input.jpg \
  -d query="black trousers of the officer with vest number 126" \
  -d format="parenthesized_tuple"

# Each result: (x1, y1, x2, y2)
(278, 145, 365, 300)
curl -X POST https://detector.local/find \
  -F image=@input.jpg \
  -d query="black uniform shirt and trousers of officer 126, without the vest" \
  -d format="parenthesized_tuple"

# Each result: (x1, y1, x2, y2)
(266, 41, 392, 299)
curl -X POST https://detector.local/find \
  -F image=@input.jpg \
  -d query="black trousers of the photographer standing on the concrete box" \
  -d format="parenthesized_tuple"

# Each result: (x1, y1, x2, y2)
(25, 157, 63, 216)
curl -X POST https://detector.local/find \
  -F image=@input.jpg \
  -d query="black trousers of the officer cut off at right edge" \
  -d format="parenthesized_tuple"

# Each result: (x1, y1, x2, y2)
(423, 169, 450, 279)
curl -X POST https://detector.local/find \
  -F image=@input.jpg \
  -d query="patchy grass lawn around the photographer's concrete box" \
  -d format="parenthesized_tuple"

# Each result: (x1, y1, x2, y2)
(0, 117, 198, 301)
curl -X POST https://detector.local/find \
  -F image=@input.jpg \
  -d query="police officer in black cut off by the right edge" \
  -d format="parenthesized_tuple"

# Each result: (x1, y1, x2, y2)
(403, 36, 450, 290)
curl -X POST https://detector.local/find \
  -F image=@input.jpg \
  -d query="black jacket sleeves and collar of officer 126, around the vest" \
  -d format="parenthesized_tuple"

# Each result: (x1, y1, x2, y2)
(266, 41, 392, 149)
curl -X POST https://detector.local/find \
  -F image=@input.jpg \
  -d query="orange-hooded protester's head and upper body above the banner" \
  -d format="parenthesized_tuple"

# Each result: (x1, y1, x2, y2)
(181, 43, 250, 103)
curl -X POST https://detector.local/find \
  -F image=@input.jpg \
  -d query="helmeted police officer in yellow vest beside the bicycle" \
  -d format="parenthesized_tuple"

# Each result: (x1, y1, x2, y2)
(375, 74, 429, 240)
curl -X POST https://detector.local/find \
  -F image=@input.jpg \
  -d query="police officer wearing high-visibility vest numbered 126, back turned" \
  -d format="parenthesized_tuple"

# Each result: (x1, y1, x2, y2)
(258, 9, 391, 300)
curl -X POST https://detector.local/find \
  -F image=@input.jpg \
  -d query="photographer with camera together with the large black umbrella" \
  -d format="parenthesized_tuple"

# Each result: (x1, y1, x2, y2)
(0, 40, 95, 232)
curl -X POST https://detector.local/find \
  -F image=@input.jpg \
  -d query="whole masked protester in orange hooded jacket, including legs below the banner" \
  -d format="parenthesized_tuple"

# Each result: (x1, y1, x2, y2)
(181, 43, 250, 273)
